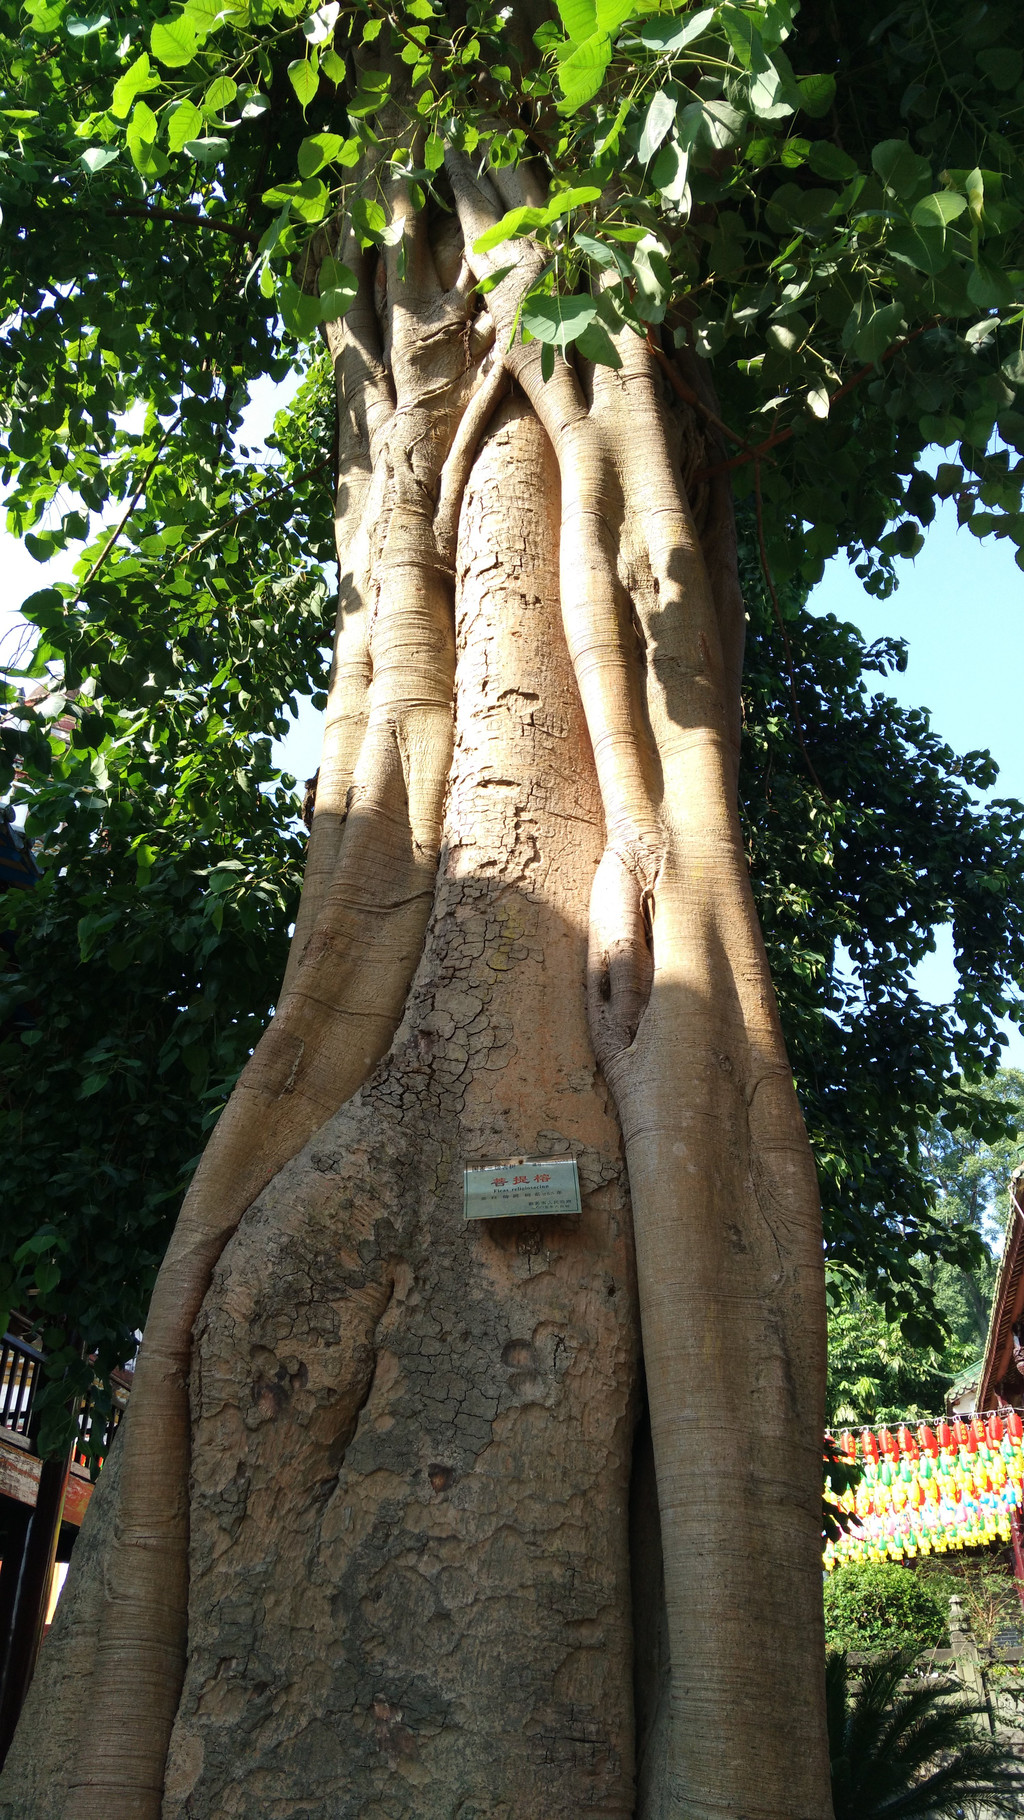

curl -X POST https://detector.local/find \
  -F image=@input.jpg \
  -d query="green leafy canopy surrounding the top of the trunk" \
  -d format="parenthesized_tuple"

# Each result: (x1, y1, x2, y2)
(0, 0, 1024, 1441)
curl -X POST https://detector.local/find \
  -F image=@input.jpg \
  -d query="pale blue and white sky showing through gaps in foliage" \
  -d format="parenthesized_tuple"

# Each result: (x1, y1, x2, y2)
(0, 405, 1024, 1067)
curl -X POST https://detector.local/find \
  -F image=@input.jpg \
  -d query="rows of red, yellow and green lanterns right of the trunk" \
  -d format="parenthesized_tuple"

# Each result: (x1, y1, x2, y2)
(824, 1409, 1024, 1571)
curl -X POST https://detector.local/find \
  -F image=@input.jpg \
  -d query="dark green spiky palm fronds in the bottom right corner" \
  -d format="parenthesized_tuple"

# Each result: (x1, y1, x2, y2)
(826, 1647, 1024, 1820)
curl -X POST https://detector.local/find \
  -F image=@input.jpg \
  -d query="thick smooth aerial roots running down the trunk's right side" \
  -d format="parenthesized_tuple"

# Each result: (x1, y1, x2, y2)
(451, 155, 829, 1820)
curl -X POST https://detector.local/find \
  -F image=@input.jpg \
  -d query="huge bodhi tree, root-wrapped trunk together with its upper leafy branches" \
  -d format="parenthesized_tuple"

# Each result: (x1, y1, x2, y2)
(0, 0, 1024, 1820)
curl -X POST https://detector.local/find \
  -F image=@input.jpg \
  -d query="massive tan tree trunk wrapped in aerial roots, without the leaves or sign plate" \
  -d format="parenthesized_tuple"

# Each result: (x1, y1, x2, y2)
(0, 173, 829, 1820)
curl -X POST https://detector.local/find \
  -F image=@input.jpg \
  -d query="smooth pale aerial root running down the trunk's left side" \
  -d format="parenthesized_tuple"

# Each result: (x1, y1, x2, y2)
(54, 195, 520, 1820)
